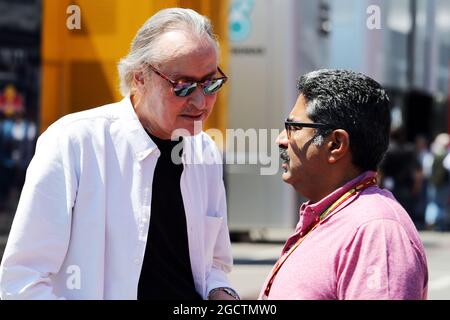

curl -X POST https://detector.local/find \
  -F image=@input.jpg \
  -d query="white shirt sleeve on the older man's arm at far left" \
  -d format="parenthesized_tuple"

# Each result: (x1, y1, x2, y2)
(0, 128, 77, 299)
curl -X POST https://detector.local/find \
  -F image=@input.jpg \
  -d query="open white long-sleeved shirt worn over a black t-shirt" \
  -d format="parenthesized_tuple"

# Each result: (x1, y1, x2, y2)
(0, 97, 232, 299)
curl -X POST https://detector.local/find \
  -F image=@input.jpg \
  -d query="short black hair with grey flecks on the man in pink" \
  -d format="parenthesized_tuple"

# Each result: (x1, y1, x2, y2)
(297, 69, 391, 171)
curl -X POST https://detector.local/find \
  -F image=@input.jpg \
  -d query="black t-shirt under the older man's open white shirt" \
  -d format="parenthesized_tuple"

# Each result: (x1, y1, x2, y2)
(138, 135, 202, 300)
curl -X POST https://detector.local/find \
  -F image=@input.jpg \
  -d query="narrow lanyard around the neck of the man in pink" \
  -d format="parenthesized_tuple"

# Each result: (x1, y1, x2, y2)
(262, 177, 377, 299)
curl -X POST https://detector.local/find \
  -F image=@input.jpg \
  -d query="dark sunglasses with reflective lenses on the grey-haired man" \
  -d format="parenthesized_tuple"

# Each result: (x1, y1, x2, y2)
(149, 65, 228, 97)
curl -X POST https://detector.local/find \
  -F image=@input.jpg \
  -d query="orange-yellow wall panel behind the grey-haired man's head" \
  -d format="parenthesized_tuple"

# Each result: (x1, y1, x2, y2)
(40, 0, 228, 136)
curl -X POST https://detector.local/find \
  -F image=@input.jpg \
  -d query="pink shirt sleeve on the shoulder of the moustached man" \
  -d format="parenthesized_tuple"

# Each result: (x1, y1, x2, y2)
(337, 219, 427, 300)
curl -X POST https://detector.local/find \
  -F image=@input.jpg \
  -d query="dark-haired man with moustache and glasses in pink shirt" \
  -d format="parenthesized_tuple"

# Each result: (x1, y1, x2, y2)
(260, 70, 428, 300)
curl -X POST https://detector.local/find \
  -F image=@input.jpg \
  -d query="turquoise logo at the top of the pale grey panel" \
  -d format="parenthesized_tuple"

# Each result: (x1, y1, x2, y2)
(229, 0, 255, 42)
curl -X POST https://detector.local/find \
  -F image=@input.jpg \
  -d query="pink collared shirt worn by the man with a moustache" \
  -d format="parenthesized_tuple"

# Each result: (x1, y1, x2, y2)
(260, 171, 428, 300)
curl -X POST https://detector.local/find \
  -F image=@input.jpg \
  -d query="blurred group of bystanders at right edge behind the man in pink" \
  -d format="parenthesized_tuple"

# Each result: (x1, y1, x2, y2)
(380, 128, 450, 231)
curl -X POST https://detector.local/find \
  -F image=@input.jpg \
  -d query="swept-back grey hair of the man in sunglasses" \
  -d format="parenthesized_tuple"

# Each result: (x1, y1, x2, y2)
(117, 8, 219, 97)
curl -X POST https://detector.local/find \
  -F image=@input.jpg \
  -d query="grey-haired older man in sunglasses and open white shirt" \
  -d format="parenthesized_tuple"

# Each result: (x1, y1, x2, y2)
(0, 8, 238, 300)
